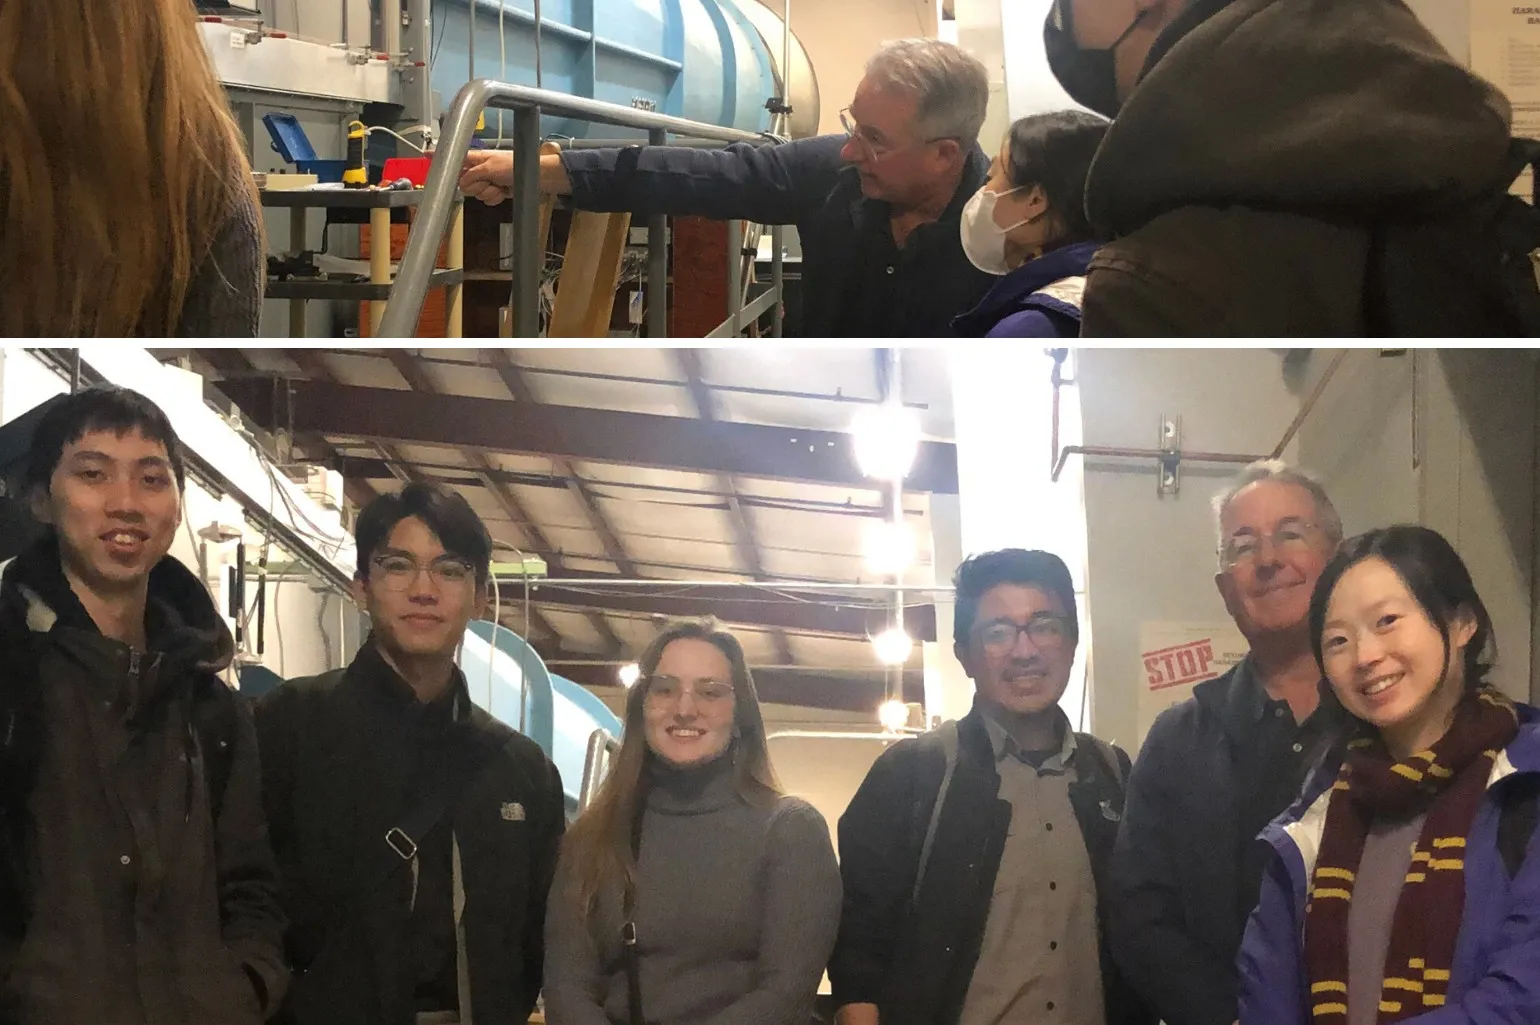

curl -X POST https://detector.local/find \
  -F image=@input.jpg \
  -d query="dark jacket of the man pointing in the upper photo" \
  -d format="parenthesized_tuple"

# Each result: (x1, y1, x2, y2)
(562, 135, 995, 337)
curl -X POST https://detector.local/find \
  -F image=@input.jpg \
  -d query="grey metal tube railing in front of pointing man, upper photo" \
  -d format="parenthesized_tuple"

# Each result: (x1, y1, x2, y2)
(379, 78, 782, 339)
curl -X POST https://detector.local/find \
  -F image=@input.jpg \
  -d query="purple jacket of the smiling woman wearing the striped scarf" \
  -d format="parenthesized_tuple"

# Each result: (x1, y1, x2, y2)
(1238, 705, 1540, 1025)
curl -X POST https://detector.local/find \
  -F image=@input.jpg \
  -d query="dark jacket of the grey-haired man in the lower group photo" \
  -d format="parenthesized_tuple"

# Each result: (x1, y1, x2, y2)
(1112, 659, 1340, 1025)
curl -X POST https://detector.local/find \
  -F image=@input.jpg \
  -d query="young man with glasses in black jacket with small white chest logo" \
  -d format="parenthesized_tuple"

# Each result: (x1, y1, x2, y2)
(257, 483, 567, 1025)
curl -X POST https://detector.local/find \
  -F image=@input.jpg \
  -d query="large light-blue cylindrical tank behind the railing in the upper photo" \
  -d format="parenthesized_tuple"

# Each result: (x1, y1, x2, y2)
(431, 0, 776, 139)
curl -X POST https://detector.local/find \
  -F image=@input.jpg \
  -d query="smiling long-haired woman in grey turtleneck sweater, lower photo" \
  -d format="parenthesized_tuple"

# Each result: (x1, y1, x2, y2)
(545, 623, 841, 1025)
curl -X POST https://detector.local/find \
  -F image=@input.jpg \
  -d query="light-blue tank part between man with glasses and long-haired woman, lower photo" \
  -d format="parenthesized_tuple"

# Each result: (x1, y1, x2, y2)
(460, 620, 621, 816)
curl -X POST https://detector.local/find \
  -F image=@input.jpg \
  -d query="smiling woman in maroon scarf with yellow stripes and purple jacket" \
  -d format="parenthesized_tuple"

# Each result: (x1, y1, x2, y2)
(1240, 526, 1540, 1025)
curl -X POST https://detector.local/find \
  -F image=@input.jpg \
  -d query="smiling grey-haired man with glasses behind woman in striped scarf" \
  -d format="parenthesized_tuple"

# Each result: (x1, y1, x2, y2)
(1112, 460, 1346, 1025)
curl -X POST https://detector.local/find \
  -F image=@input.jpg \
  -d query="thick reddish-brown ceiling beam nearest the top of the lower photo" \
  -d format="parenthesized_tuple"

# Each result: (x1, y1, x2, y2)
(214, 375, 958, 494)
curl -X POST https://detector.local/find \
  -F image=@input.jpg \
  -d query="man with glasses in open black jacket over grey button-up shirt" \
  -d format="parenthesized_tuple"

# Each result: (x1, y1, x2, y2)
(829, 549, 1150, 1025)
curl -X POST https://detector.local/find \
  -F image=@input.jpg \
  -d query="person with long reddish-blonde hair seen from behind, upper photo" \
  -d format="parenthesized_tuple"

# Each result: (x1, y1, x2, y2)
(0, 0, 263, 337)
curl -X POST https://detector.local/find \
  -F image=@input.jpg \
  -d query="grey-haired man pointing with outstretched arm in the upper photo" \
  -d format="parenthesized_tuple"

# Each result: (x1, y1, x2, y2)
(460, 38, 995, 339)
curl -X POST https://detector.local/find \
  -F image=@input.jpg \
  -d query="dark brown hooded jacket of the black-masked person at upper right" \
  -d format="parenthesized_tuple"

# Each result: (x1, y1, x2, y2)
(1083, 0, 1511, 337)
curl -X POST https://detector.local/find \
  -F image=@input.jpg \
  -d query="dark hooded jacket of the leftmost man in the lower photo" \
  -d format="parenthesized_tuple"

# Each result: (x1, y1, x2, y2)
(0, 534, 288, 1025)
